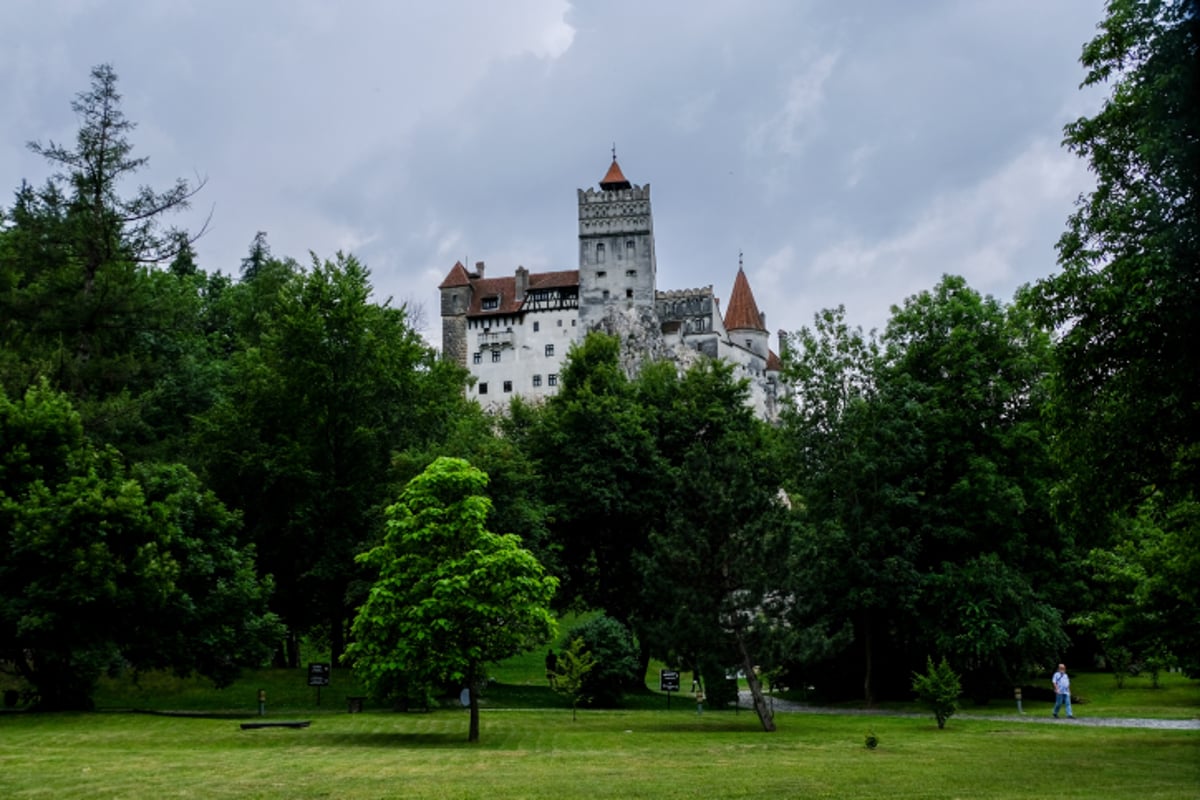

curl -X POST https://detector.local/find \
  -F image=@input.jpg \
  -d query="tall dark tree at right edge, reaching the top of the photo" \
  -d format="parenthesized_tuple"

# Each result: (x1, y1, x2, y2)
(1032, 0, 1200, 676)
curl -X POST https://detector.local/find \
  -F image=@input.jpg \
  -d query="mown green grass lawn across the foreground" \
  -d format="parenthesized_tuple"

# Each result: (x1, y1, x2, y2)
(0, 654, 1200, 800)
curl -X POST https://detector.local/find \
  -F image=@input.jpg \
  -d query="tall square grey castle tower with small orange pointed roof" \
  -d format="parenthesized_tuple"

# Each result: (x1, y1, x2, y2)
(578, 151, 658, 331)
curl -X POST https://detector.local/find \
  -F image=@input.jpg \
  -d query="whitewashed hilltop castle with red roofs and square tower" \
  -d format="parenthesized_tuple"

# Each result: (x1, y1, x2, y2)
(438, 154, 782, 419)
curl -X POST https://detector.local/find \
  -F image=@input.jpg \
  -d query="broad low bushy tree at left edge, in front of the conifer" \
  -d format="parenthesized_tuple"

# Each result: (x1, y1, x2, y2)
(0, 384, 280, 709)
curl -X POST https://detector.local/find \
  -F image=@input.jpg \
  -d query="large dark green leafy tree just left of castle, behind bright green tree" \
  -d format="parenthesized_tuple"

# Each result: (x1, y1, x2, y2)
(197, 253, 463, 664)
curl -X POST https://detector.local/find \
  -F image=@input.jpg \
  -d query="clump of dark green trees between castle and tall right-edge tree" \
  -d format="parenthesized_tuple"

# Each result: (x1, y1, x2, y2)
(785, 276, 1073, 703)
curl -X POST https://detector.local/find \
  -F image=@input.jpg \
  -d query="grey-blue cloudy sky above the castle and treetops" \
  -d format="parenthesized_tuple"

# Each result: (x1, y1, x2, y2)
(0, 0, 1103, 342)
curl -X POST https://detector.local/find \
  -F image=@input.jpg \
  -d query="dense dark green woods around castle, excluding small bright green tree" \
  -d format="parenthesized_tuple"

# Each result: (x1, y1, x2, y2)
(0, 0, 1200, 709)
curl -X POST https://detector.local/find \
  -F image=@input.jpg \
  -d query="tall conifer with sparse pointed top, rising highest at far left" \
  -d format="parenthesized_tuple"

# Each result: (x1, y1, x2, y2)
(0, 65, 212, 457)
